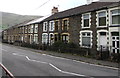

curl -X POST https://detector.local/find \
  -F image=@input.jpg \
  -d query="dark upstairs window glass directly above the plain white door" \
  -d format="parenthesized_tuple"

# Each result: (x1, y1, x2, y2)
(98, 11, 106, 26)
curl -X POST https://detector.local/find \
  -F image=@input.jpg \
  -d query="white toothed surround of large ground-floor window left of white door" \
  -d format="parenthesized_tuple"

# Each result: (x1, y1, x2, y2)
(79, 30, 93, 48)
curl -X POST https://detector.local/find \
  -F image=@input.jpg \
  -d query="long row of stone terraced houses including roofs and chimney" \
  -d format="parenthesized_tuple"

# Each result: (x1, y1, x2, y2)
(3, 2, 120, 53)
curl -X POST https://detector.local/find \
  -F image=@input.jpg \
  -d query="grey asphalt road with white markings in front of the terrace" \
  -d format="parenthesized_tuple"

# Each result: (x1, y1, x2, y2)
(0, 44, 118, 78)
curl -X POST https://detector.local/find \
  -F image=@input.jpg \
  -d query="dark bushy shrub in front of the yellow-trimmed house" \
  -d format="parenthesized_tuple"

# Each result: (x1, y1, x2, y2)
(48, 41, 87, 55)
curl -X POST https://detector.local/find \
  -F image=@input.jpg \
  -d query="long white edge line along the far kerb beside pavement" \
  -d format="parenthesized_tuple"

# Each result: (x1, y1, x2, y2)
(42, 54, 119, 70)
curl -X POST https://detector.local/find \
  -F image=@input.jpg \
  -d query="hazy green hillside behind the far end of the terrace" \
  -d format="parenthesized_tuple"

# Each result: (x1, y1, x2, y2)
(0, 12, 42, 29)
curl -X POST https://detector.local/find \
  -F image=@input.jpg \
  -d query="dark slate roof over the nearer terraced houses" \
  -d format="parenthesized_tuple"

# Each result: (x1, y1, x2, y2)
(44, 2, 119, 21)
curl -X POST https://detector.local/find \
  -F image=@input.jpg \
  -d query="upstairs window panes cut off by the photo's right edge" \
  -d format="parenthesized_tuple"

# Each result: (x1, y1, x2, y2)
(111, 9, 120, 25)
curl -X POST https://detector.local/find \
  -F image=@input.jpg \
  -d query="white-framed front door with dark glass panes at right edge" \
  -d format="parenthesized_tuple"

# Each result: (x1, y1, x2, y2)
(112, 33, 120, 53)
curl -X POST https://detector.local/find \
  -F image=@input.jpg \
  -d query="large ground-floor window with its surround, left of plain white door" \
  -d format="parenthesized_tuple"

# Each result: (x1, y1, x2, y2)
(80, 30, 92, 48)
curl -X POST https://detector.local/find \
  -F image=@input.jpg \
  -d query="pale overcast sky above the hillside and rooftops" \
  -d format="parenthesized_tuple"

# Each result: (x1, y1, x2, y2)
(0, 0, 87, 16)
